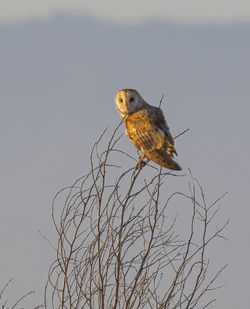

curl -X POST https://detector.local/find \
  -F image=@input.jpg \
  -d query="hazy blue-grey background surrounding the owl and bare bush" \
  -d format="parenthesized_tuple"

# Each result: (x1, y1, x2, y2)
(0, 1, 250, 308)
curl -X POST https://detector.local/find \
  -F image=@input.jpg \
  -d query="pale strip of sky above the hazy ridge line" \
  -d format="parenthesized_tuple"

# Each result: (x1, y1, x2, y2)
(0, 0, 250, 25)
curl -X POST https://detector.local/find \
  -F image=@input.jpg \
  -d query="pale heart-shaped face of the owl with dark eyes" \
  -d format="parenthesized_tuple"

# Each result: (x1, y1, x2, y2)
(115, 89, 140, 117)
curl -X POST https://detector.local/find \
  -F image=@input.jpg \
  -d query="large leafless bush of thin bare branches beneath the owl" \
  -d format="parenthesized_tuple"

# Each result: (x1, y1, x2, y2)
(44, 123, 228, 309)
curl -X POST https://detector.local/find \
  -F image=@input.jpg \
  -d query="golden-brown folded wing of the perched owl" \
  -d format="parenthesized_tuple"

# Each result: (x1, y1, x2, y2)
(124, 106, 176, 161)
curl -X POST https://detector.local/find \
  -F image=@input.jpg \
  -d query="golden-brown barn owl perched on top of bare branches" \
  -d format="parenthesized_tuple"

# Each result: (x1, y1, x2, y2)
(115, 89, 181, 170)
